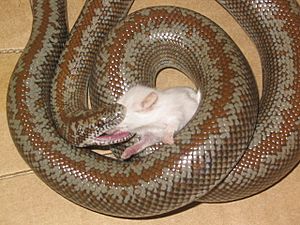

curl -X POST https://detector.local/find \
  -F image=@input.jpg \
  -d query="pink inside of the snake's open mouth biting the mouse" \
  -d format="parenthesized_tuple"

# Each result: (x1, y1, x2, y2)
(95, 130, 135, 145)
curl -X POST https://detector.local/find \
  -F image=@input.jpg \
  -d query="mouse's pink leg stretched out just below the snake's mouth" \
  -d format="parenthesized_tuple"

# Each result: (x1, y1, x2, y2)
(121, 133, 159, 159)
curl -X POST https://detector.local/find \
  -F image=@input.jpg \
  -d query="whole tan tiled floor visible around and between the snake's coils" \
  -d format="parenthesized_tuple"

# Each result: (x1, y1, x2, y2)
(0, 0, 300, 225)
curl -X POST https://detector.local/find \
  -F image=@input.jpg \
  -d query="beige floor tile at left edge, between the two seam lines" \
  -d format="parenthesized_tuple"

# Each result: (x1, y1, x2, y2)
(0, 54, 29, 176)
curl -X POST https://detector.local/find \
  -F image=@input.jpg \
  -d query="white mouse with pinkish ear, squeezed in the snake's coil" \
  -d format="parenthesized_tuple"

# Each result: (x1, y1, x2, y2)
(99, 85, 201, 159)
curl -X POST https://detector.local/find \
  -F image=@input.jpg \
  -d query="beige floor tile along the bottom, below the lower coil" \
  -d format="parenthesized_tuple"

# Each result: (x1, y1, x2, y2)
(0, 168, 300, 225)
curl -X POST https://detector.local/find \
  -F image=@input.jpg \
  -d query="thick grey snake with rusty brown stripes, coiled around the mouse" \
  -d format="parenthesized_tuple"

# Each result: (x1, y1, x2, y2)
(7, 0, 300, 217)
